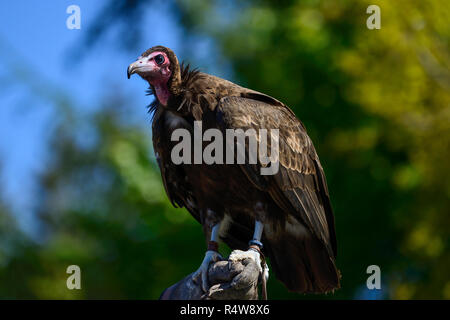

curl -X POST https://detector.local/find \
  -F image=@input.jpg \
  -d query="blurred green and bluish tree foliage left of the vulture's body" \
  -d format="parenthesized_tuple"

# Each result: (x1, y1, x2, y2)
(0, 97, 204, 299)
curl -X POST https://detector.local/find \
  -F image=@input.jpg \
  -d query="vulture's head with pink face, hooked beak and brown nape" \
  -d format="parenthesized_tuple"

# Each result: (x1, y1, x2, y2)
(127, 46, 181, 105)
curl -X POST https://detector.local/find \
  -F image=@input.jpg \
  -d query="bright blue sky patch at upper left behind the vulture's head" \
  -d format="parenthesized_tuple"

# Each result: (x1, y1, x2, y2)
(0, 0, 186, 235)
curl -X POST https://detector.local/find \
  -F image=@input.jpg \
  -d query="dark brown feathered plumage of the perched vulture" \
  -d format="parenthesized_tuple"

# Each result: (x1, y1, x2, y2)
(128, 46, 340, 293)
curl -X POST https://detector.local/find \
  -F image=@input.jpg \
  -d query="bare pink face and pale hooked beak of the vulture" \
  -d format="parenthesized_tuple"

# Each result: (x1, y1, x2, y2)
(128, 51, 172, 86)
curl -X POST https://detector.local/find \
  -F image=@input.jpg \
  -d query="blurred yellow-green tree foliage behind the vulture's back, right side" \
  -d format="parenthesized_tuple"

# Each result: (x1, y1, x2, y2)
(171, 0, 450, 299)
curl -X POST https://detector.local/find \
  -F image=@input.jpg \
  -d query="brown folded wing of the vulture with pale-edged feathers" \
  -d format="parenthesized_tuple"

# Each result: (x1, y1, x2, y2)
(216, 94, 336, 256)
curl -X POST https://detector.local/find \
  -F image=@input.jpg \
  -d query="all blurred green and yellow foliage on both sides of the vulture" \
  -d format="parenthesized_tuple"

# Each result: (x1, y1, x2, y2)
(0, 0, 450, 299)
